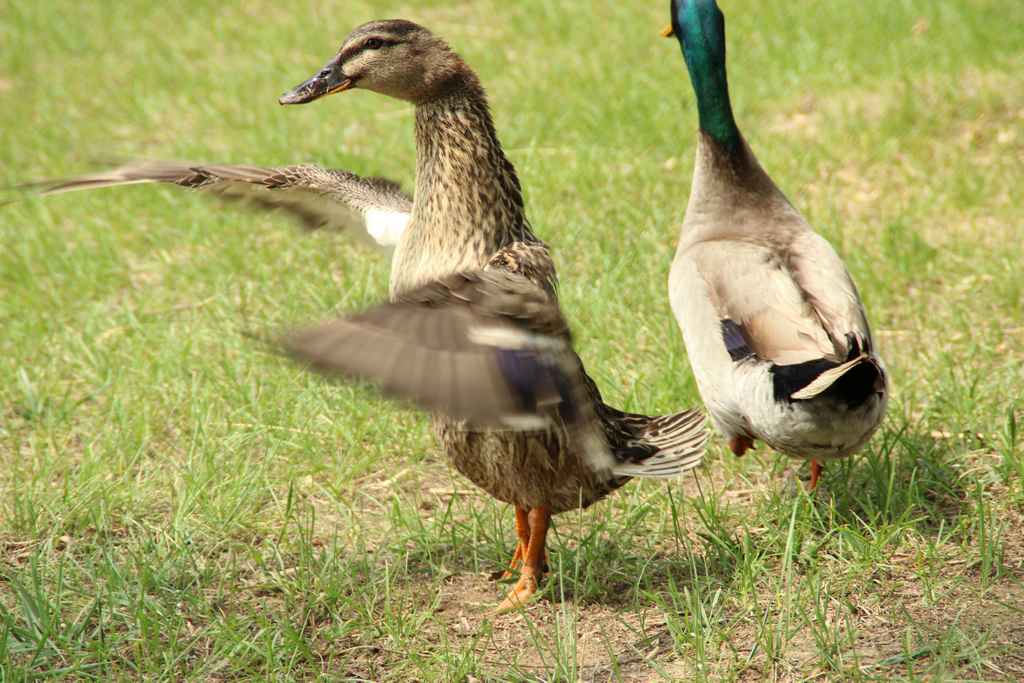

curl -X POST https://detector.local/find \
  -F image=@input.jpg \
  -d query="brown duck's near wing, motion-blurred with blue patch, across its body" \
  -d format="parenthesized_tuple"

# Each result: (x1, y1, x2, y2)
(284, 270, 612, 470)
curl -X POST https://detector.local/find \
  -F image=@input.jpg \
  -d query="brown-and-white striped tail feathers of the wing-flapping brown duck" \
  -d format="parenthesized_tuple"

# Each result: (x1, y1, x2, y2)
(608, 410, 708, 479)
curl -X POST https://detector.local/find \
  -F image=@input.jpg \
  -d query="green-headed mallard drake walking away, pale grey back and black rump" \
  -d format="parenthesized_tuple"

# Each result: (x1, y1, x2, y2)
(665, 0, 888, 488)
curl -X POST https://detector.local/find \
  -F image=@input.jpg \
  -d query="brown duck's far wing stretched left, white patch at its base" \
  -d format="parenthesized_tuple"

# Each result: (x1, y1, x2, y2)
(24, 161, 413, 248)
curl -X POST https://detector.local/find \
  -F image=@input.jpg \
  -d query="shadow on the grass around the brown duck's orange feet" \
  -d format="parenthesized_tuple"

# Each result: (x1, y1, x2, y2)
(364, 485, 743, 606)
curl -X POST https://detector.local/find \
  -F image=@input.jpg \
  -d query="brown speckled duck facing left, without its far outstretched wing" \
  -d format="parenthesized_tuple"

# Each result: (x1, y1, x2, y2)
(281, 20, 706, 610)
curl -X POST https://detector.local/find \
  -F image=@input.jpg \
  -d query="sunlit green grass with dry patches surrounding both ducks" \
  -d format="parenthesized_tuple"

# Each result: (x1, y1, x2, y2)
(0, 0, 1024, 681)
